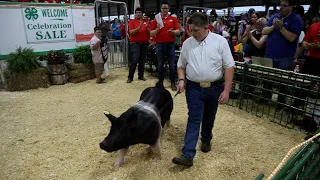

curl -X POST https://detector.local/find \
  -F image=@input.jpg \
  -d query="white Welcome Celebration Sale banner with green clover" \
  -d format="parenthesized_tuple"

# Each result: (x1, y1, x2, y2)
(22, 6, 75, 44)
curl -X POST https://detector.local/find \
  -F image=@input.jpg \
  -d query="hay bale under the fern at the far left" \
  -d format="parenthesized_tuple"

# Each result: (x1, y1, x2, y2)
(4, 68, 51, 91)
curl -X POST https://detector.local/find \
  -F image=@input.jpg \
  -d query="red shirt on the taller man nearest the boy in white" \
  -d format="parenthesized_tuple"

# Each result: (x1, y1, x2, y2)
(149, 15, 180, 43)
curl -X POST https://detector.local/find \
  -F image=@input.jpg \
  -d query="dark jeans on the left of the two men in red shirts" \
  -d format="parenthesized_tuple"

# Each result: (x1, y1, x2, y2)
(128, 42, 148, 80)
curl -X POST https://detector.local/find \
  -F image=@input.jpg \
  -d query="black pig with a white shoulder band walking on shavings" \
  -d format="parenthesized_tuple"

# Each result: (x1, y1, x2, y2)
(100, 85, 173, 167)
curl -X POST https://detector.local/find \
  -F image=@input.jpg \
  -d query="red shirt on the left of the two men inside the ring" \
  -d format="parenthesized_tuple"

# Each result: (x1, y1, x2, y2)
(128, 19, 150, 42)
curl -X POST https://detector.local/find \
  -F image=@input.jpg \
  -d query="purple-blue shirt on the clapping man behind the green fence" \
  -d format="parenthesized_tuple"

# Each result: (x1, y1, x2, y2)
(266, 13, 303, 57)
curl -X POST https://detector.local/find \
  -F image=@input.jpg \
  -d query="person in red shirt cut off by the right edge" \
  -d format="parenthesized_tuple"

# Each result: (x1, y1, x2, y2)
(302, 22, 320, 76)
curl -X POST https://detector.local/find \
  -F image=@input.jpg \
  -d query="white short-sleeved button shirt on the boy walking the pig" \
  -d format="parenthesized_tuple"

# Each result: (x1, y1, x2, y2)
(177, 32, 235, 82)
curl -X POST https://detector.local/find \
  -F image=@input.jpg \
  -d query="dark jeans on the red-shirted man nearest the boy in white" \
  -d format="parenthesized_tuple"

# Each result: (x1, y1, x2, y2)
(156, 43, 176, 83)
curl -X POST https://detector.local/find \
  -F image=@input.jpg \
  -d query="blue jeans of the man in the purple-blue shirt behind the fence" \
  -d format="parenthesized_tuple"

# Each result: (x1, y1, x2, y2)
(263, 55, 294, 108)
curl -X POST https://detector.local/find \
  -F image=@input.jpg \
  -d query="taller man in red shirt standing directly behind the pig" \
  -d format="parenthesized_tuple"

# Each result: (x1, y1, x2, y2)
(150, 1, 180, 91)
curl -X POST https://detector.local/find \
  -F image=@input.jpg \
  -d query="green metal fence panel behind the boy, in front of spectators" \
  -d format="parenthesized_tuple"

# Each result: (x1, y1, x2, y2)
(228, 62, 320, 132)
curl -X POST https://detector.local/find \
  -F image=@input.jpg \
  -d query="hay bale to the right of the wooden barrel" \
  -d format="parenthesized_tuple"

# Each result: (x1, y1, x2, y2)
(67, 64, 96, 83)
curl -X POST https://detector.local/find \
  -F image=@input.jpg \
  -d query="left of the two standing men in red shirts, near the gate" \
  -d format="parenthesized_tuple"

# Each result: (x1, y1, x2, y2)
(127, 7, 150, 83)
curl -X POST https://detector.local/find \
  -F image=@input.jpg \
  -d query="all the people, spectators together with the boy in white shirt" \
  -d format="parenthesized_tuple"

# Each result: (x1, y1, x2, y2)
(91, 0, 320, 166)
